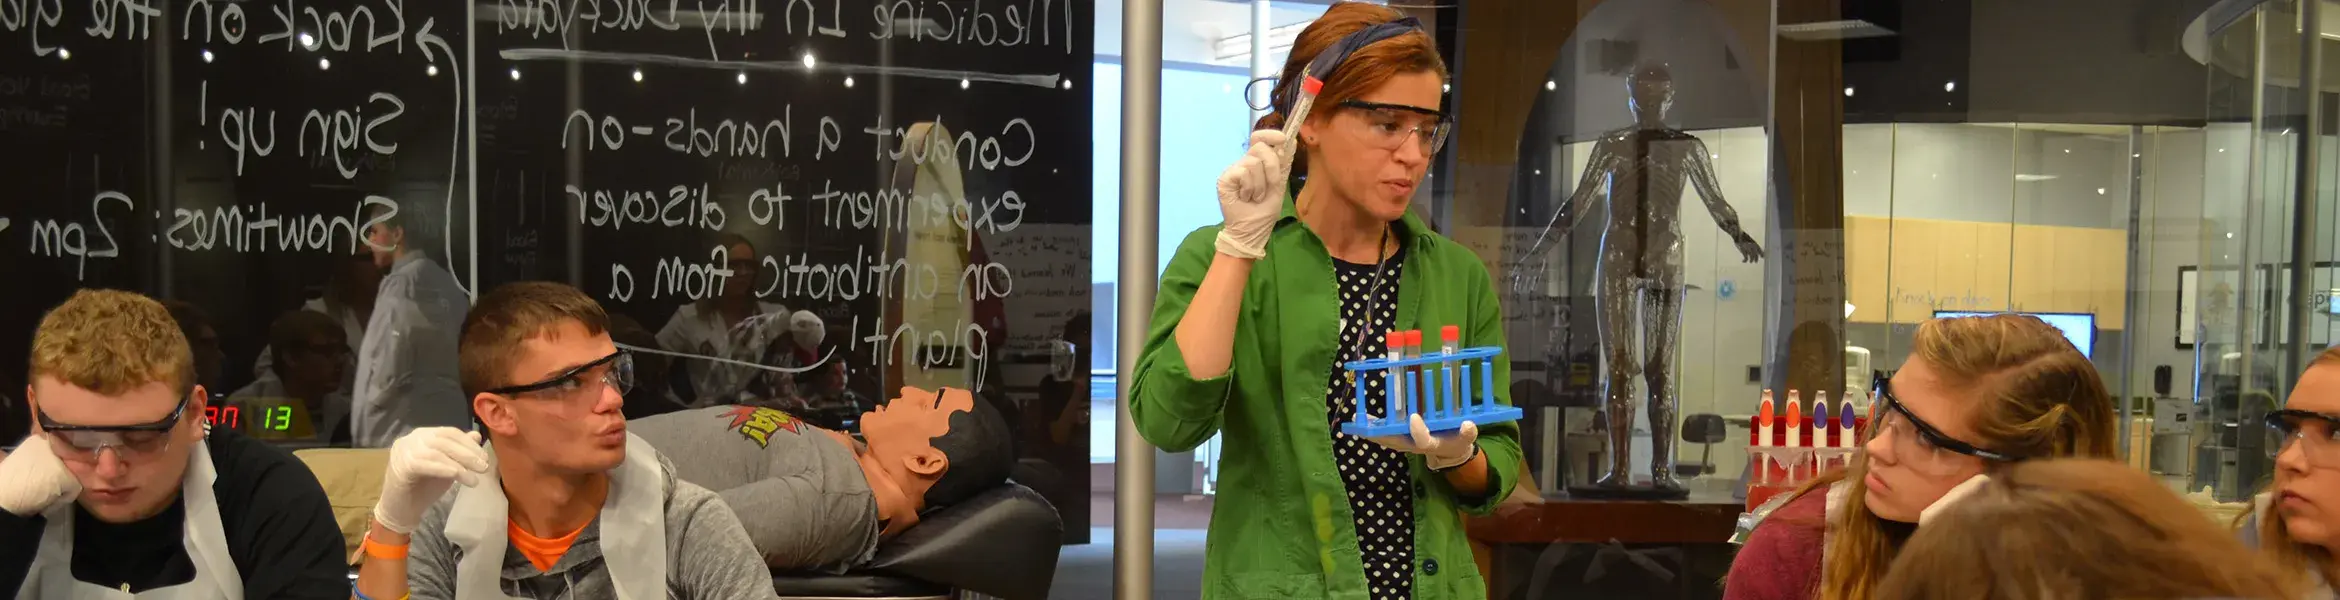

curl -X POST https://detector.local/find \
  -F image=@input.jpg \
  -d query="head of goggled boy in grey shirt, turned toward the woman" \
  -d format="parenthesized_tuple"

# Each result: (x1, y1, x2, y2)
(456, 281, 634, 476)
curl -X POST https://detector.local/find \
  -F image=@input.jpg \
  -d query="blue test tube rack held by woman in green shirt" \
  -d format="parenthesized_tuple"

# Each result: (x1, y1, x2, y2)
(1341, 347, 1526, 436)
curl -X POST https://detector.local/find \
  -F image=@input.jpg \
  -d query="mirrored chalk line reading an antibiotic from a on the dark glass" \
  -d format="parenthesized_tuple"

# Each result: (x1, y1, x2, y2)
(604, 246, 1016, 302)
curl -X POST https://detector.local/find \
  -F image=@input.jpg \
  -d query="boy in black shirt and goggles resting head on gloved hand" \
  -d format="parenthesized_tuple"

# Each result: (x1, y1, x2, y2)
(0, 291, 349, 600)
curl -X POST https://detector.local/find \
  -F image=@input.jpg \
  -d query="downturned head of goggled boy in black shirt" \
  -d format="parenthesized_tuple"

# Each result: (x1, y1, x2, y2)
(26, 291, 208, 523)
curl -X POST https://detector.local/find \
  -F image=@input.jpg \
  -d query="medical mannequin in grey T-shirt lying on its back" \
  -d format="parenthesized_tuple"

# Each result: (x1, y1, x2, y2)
(627, 387, 1016, 572)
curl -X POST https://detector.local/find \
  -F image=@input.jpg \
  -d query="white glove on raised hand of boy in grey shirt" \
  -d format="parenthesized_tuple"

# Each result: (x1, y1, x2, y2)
(374, 427, 487, 534)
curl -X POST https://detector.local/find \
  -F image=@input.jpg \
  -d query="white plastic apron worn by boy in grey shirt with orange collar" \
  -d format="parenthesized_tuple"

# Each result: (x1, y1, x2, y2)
(447, 434, 667, 600)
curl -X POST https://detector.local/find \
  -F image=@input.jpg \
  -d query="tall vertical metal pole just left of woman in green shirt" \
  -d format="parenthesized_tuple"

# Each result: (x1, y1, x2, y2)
(1114, 0, 1163, 600)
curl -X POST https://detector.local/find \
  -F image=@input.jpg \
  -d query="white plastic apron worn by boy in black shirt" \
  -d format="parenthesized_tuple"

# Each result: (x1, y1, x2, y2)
(16, 441, 243, 600)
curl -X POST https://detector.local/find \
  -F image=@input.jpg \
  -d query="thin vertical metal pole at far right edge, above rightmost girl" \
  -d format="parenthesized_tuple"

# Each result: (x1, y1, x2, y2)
(2284, 0, 2324, 377)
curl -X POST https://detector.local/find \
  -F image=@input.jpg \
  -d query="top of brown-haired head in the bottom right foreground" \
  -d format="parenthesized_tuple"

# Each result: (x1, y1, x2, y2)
(1877, 459, 2303, 600)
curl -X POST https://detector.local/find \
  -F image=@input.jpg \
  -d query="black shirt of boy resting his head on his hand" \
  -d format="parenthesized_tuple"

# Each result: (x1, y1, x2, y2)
(0, 429, 349, 598)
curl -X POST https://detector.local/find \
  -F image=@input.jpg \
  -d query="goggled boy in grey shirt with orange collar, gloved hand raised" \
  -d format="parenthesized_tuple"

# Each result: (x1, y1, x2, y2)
(358, 281, 775, 600)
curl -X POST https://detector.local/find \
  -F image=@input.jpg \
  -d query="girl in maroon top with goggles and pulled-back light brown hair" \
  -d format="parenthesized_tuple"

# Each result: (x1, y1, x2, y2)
(1722, 314, 2115, 600)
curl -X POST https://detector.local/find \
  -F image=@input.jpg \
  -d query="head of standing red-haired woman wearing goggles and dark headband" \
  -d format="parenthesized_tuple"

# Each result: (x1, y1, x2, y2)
(1254, 2, 1446, 227)
